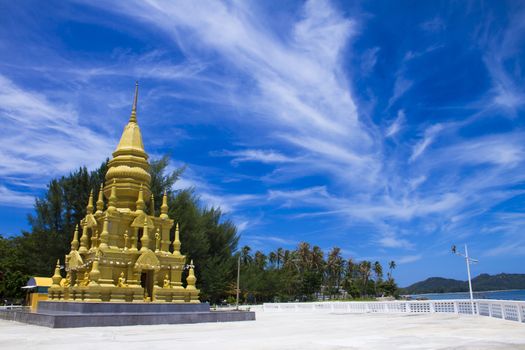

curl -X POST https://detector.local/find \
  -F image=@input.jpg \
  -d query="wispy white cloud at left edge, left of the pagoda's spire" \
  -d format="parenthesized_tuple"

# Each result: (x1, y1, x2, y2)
(0, 75, 112, 186)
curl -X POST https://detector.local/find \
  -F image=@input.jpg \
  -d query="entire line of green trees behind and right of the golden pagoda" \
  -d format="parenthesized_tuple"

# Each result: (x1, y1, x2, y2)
(0, 156, 397, 303)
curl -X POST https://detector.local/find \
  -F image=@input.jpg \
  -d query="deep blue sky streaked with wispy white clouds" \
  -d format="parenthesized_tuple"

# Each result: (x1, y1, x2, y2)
(0, 0, 525, 285)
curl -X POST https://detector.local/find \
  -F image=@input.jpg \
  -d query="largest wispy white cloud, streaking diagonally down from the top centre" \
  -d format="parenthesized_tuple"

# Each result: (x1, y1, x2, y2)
(88, 1, 379, 189)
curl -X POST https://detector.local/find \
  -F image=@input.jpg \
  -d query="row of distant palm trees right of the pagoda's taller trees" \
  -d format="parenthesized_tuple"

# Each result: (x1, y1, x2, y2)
(233, 242, 398, 303)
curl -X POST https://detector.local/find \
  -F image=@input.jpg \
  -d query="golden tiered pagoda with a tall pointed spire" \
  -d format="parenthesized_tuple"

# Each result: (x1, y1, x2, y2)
(49, 83, 199, 303)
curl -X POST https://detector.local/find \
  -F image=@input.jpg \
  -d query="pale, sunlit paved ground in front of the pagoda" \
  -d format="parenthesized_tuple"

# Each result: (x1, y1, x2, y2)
(0, 312, 525, 350)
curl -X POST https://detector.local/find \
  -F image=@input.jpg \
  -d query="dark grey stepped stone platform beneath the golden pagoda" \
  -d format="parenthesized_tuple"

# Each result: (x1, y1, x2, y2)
(0, 301, 255, 328)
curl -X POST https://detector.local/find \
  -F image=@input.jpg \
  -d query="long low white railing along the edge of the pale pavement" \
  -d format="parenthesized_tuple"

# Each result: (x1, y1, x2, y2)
(263, 299, 525, 323)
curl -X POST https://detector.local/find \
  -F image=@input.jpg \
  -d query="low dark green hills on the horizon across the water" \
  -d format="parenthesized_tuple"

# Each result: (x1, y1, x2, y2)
(400, 273, 525, 294)
